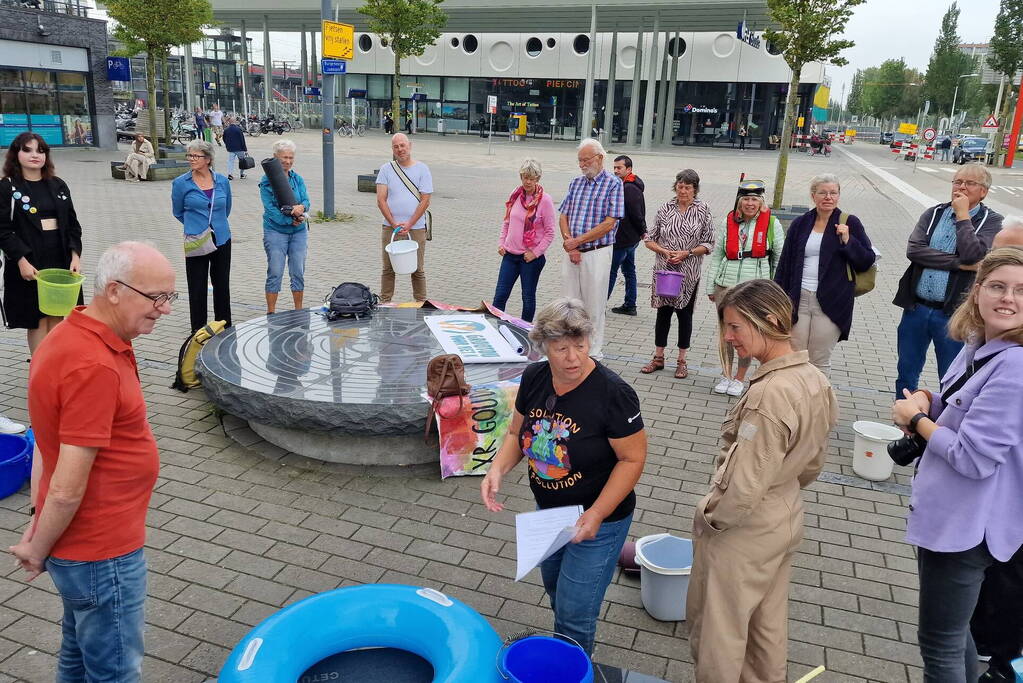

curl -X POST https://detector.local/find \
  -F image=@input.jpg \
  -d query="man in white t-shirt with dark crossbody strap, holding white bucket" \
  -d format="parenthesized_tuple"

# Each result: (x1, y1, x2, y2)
(376, 132, 434, 303)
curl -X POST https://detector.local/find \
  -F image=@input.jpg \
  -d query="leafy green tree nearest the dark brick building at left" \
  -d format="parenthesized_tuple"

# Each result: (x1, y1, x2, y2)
(104, 0, 214, 144)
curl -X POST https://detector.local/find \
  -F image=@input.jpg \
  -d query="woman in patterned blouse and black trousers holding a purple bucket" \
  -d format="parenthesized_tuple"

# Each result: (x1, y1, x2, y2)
(640, 169, 714, 379)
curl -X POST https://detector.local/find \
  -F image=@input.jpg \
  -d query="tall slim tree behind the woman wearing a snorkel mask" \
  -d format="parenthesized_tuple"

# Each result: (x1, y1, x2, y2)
(764, 0, 865, 208)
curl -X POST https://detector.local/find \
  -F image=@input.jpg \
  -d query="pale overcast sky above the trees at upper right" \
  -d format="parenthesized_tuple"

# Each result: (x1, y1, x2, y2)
(827, 0, 999, 99)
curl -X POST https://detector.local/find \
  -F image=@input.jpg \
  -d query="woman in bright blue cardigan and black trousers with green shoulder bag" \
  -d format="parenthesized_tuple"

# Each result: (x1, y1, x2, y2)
(171, 140, 231, 332)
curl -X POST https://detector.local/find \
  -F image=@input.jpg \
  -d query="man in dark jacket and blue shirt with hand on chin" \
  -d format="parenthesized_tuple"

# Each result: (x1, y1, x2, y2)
(892, 164, 1002, 399)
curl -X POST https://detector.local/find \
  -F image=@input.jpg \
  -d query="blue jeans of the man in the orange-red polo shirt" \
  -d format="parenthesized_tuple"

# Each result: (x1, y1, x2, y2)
(46, 548, 145, 683)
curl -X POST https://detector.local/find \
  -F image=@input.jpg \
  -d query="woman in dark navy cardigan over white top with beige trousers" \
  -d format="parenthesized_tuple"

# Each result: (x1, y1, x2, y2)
(774, 173, 876, 374)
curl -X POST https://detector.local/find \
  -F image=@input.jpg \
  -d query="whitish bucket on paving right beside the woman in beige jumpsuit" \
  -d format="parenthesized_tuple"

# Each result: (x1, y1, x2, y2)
(636, 534, 693, 622)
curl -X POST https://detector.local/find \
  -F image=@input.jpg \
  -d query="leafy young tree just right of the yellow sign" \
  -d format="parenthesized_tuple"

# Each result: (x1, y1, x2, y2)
(359, 0, 447, 129)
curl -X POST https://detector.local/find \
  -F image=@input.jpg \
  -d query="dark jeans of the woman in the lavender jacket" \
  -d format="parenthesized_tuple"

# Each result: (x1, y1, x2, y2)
(917, 541, 994, 683)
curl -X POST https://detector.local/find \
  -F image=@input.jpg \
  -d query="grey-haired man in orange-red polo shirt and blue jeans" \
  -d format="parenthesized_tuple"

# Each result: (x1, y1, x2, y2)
(10, 242, 178, 683)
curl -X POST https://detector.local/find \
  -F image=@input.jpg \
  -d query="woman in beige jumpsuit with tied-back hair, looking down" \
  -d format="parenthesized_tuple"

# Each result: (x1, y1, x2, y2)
(685, 279, 838, 683)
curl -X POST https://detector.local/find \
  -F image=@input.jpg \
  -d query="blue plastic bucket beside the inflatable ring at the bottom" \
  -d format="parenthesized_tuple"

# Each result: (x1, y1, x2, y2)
(498, 636, 593, 683)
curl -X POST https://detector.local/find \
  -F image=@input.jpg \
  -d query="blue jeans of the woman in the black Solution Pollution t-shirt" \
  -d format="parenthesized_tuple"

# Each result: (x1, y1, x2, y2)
(540, 514, 632, 654)
